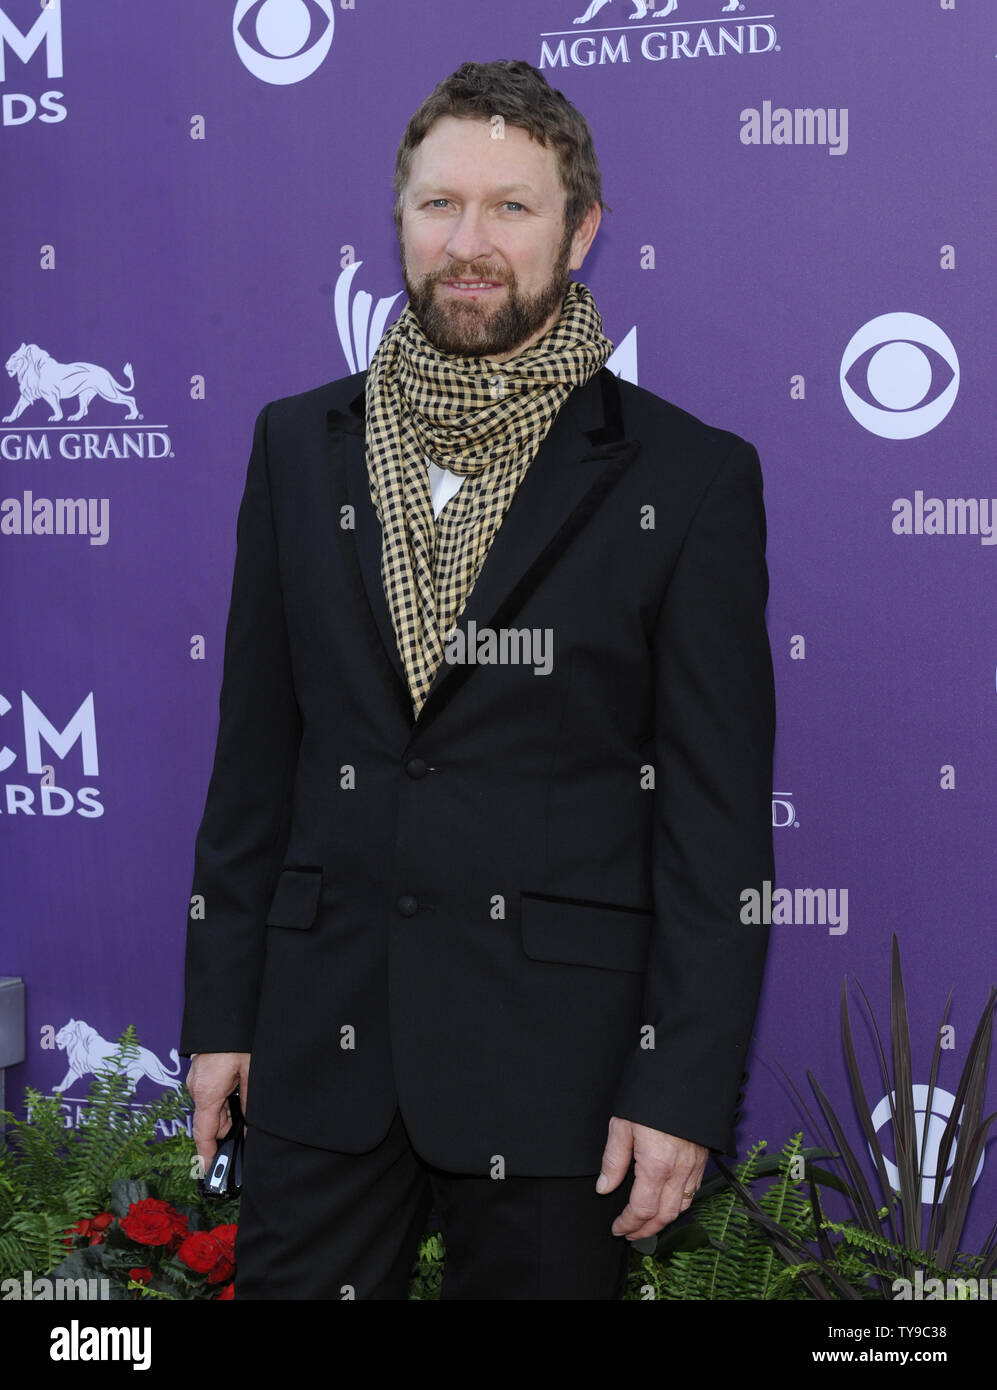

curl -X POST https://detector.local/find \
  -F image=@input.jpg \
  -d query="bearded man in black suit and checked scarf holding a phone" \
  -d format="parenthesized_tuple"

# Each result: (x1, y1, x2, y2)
(182, 63, 775, 1300)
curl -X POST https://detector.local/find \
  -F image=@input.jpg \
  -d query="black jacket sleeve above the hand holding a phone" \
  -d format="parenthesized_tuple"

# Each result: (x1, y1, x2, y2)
(181, 406, 302, 1055)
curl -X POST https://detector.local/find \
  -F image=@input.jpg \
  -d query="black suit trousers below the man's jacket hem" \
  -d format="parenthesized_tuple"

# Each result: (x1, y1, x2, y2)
(235, 1111, 633, 1301)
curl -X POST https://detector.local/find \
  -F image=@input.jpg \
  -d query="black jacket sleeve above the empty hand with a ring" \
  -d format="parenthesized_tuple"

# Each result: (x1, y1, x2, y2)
(613, 441, 775, 1152)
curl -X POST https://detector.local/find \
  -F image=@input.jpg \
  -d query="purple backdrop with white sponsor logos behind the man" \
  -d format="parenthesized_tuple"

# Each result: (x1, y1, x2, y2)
(0, 0, 997, 1251)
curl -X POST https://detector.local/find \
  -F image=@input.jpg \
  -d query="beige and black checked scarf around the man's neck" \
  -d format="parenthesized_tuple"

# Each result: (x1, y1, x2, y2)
(366, 281, 613, 716)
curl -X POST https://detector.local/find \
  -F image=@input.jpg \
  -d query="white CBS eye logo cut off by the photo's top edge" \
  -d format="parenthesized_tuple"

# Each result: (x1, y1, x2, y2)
(232, 0, 334, 86)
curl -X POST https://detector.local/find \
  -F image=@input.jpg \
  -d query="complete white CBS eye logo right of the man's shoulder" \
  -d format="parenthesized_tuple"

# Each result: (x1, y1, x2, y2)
(840, 314, 959, 439)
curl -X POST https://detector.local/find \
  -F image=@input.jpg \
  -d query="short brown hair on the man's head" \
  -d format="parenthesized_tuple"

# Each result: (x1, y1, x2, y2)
(394, 60, 609, 238)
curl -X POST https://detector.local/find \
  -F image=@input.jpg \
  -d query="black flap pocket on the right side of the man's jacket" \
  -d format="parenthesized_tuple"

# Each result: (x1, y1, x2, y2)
(520, 894, 654, 973)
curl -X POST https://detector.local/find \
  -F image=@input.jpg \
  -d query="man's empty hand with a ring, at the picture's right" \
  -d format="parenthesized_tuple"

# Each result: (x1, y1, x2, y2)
(595, 1115, 708, 1240)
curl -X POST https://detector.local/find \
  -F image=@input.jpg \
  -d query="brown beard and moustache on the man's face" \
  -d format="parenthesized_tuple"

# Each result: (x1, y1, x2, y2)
(402, 235, 572, 357)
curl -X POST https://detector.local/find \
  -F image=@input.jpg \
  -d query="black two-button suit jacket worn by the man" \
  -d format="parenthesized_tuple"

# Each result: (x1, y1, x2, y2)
(181, 370, 773, 1176)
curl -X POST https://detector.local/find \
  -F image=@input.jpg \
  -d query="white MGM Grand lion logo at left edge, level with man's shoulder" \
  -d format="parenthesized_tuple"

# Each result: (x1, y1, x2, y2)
(0, 343, 172, 461)
